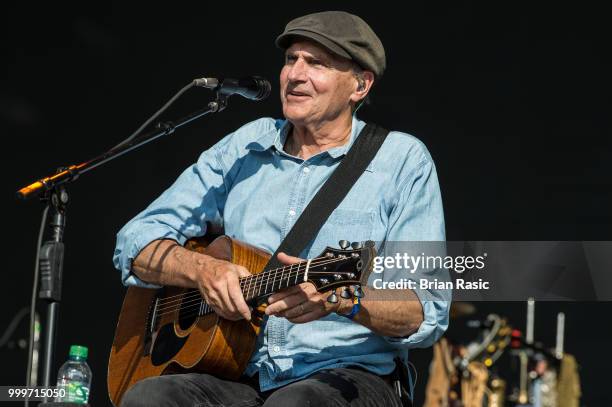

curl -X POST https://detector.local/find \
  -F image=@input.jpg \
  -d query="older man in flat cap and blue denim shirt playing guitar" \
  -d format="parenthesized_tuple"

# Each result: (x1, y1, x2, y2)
(115, 12, 448, 406)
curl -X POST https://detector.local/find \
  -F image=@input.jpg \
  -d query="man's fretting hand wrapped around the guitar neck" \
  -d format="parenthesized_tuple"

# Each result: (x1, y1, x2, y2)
(266, 252, 340, 324)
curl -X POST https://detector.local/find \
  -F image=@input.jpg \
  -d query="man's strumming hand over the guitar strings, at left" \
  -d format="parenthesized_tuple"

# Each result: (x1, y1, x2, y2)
(195, 256, 251, 321)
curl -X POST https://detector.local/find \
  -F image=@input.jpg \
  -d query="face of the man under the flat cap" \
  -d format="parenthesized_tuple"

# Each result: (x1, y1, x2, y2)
(280, 40, 357, 125)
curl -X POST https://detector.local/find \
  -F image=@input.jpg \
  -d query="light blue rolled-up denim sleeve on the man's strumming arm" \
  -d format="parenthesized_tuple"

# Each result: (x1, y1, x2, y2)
(113, 145, 231, 288)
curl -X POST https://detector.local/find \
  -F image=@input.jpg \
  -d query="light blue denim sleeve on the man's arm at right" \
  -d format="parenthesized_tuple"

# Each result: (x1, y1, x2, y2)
(383, 155, 452, 348)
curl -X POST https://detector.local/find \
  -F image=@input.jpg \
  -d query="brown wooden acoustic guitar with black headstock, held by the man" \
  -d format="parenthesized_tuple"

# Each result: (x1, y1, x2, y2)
(108, 236, 375, 406)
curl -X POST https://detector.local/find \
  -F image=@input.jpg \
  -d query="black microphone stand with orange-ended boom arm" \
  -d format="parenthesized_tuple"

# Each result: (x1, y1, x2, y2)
(17, 92, 229, 406)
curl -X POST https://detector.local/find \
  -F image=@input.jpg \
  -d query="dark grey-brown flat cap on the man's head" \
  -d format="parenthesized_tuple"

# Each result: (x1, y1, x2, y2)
(276, 11, 386, 78)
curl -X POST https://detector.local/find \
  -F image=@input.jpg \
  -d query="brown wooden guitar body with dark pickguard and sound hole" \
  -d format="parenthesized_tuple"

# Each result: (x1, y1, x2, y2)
(108, 236, 270, 406)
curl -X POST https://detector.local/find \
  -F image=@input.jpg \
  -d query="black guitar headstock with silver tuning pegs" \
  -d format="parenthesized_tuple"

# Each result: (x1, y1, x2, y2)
(308, 240, 376, 291)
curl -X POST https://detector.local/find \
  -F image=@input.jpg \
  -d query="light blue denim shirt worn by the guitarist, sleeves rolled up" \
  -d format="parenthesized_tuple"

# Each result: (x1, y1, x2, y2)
(114, 117, 450, 391)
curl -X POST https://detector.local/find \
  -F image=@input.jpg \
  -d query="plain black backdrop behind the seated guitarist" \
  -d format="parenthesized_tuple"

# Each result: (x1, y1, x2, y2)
(0, 2, 612, 406)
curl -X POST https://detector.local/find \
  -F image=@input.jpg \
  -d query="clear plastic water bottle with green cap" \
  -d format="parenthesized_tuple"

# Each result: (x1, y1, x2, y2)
(55, 345, 91, 404)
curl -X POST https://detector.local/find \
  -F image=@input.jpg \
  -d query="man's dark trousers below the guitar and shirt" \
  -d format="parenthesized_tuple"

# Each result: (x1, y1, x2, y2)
(121, 368, 401, 407)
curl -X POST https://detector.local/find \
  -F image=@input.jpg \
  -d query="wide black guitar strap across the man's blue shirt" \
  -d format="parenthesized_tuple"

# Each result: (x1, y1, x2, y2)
(264, 123, 389, 270)
